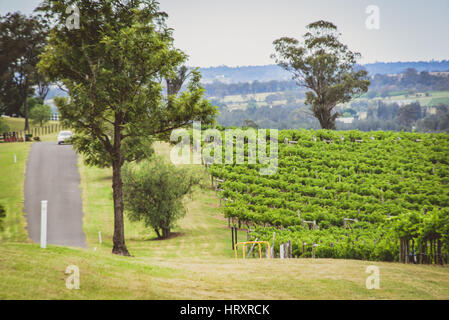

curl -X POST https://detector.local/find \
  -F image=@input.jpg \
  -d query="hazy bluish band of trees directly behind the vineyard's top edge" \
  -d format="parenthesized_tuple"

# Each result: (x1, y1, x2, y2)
(213, 97, 449, 133)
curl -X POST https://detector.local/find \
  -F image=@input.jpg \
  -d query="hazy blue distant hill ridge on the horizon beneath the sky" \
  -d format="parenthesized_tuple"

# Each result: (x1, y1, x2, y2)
(200, 60, 449, 83)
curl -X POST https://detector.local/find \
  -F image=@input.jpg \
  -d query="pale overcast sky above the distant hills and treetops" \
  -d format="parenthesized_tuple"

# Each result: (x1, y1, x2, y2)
(0, 0, 449, 67)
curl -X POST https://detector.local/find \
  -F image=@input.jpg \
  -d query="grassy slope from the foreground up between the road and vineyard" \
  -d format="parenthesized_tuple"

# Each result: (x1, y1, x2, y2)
(0, 140, 449, 299)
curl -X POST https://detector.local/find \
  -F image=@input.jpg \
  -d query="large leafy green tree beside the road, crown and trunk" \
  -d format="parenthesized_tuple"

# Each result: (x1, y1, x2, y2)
(39, 0, 216, 255)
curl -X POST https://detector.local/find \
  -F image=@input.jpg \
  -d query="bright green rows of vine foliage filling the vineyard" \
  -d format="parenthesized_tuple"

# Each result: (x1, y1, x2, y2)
(209, 130, 449, 261)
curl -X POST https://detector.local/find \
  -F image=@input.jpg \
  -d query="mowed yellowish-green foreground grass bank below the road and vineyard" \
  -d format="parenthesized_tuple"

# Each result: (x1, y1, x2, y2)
(0, 243, 449, 300)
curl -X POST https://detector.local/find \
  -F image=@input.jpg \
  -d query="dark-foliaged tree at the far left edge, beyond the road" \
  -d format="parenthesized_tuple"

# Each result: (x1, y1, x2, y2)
(0, 12, 48, 130)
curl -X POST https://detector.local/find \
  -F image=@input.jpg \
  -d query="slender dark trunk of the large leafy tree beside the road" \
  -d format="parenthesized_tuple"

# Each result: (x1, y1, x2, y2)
(112, 116, 130, 256)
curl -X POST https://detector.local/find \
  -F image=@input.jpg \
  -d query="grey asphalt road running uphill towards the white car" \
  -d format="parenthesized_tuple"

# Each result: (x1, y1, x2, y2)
(25, 142, 86, 248)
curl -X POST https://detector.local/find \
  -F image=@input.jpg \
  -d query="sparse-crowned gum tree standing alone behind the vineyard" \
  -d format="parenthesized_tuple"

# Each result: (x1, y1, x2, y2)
(271, 21, 370, 129)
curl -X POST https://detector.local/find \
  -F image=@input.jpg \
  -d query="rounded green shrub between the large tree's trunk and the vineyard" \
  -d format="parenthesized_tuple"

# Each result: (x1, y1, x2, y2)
(122, 156, 200, 239)
